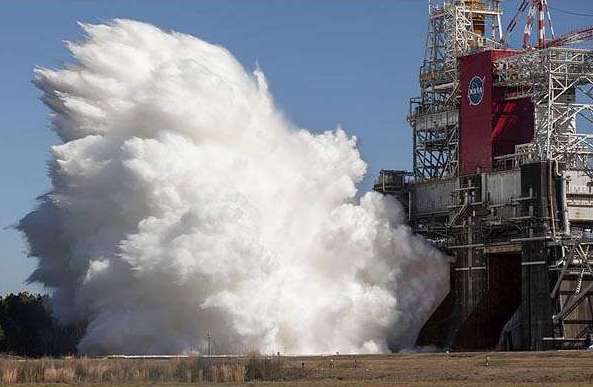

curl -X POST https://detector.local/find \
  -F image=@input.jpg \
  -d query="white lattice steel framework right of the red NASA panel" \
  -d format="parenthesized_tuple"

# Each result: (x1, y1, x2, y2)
(495, 47, 593, 171)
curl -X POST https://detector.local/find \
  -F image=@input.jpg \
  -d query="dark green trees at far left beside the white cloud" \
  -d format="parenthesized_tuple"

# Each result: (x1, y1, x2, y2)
(0, 292, 85, 357)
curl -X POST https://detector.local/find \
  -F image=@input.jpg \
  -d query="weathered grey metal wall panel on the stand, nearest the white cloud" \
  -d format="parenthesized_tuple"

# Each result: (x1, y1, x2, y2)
(412, 178, 459, 214)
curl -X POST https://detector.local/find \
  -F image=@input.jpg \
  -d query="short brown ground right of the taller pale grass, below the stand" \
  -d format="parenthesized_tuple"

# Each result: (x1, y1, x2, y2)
(9, 351, 593, 387)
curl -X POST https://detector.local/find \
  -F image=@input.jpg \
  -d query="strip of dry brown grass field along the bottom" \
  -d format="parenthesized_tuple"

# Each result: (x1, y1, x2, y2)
(0, 351, 593, 387)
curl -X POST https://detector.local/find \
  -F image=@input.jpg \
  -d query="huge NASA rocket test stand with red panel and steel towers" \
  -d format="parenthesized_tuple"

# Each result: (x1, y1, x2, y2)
(375, 0, 593, 350)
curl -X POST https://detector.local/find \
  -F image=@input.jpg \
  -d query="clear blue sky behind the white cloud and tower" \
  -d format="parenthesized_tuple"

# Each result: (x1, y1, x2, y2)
(0, 0, 593, 295)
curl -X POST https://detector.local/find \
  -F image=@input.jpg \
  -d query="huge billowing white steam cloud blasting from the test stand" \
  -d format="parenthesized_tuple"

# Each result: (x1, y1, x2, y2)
(18, 20, 448, 354)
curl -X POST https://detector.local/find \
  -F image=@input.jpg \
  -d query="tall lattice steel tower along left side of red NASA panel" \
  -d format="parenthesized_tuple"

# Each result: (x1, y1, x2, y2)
(408, 0, 502, 180)
